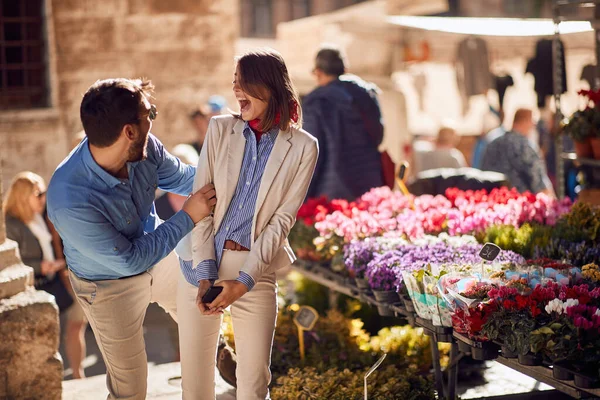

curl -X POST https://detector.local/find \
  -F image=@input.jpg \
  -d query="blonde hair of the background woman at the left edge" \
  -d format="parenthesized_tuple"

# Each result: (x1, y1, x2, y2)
(3, 171, 46, 223)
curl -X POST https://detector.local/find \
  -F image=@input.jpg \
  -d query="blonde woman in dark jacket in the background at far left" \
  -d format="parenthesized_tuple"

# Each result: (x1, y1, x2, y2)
(3, 172, 87, 379)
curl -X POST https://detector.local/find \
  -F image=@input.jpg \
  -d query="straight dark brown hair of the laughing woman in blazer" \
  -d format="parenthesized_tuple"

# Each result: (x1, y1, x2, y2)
(236, 48, 302, 132)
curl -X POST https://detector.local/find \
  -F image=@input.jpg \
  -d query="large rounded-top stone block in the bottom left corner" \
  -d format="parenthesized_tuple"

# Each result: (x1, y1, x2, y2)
(0, 289, 62, 400)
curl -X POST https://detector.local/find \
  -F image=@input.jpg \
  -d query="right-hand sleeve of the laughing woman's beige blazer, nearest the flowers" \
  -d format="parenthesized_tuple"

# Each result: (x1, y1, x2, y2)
(240, 140, 319, 282)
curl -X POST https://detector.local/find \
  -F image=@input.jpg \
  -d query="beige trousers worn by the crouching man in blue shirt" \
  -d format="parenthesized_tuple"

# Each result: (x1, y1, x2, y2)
(69, 253, 181, 400)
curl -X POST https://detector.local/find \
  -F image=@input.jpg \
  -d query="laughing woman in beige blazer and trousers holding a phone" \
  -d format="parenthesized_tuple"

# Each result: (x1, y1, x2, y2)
(177, 49, 318, 400)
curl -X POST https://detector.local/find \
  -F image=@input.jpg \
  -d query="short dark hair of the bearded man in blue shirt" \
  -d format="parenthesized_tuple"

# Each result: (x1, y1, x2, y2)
(79, 78, 154, 147)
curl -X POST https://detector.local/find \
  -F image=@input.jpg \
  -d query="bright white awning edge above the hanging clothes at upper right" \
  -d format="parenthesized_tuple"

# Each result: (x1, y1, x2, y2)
(386, 15, 593, 37)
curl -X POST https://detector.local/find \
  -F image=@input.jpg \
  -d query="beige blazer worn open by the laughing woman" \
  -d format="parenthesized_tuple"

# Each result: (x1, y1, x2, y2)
(189, 115, 319, 282)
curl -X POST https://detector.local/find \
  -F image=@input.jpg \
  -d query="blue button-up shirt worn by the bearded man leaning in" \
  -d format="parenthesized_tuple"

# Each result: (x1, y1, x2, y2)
(48, 134, 196, 280)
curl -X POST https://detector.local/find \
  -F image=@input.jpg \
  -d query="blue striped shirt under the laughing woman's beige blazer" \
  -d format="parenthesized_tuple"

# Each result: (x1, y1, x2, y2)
(180, 123, 279, 290)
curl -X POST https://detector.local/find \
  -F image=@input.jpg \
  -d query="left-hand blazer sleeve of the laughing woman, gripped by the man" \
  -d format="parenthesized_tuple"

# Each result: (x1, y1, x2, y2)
(188, 119, 220, 273)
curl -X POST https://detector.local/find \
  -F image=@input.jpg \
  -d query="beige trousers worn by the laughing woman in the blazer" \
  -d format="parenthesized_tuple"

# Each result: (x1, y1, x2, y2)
(177, 250, 277, 400)
